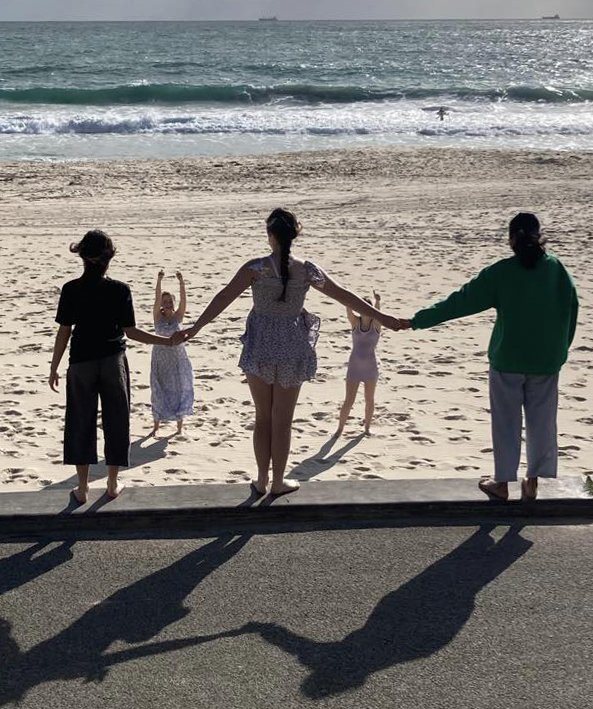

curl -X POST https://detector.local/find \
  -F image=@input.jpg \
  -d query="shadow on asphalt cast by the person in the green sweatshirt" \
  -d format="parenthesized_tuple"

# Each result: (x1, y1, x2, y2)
(243, 528, 533, 700)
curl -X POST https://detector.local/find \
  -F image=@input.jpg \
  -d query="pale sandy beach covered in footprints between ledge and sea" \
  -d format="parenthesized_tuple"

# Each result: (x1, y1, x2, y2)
(0, 149, 593, 492)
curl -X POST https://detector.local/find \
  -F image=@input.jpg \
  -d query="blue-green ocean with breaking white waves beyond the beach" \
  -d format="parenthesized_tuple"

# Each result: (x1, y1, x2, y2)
(0, 20, 593, 160)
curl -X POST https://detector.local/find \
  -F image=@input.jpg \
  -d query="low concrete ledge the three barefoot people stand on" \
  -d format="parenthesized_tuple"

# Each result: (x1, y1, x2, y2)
(0, 476, 593, 535)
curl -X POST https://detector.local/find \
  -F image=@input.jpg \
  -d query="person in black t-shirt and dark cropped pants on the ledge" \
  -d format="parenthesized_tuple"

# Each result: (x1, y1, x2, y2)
(49, 230, 182, 503)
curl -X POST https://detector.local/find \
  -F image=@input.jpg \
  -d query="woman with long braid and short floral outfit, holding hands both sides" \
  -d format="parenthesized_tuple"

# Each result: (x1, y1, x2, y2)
(185, 209, 399, 495)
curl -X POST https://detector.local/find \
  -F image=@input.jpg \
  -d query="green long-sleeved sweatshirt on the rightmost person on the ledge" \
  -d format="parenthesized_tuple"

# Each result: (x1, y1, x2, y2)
(412, 254, 579, 375)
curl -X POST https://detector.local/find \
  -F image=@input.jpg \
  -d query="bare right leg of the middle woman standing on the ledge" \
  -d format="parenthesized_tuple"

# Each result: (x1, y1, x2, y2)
(272, 384, 301, 495)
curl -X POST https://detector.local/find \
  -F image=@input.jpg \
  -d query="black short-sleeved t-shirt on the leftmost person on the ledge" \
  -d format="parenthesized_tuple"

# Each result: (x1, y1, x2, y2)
(56, 275, 136, 363)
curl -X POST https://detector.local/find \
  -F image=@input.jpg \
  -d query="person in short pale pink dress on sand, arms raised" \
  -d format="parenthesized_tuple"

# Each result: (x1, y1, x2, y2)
(335, 292, 381, 437)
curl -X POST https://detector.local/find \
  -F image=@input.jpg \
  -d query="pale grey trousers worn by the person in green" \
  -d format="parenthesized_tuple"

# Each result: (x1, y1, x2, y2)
(490, 367, 558, 482)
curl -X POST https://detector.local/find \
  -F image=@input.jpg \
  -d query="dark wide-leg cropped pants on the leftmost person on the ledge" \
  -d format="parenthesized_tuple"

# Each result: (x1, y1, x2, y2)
(64, 352, 130, 467)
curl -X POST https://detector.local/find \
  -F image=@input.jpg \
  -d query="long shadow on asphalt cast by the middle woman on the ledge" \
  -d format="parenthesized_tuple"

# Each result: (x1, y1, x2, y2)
(0, 534, 251, 706)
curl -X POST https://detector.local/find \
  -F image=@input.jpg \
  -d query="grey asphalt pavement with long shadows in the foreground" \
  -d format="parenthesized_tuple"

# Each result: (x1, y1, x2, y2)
(0, 522, 593, 709)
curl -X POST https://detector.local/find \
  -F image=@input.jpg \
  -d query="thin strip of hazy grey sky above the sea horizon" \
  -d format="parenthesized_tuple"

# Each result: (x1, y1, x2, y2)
(0, 0, 593, 20)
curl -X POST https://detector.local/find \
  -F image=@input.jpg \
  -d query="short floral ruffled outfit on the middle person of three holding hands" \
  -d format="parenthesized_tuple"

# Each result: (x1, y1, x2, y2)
(239, 256, 325, 388)
